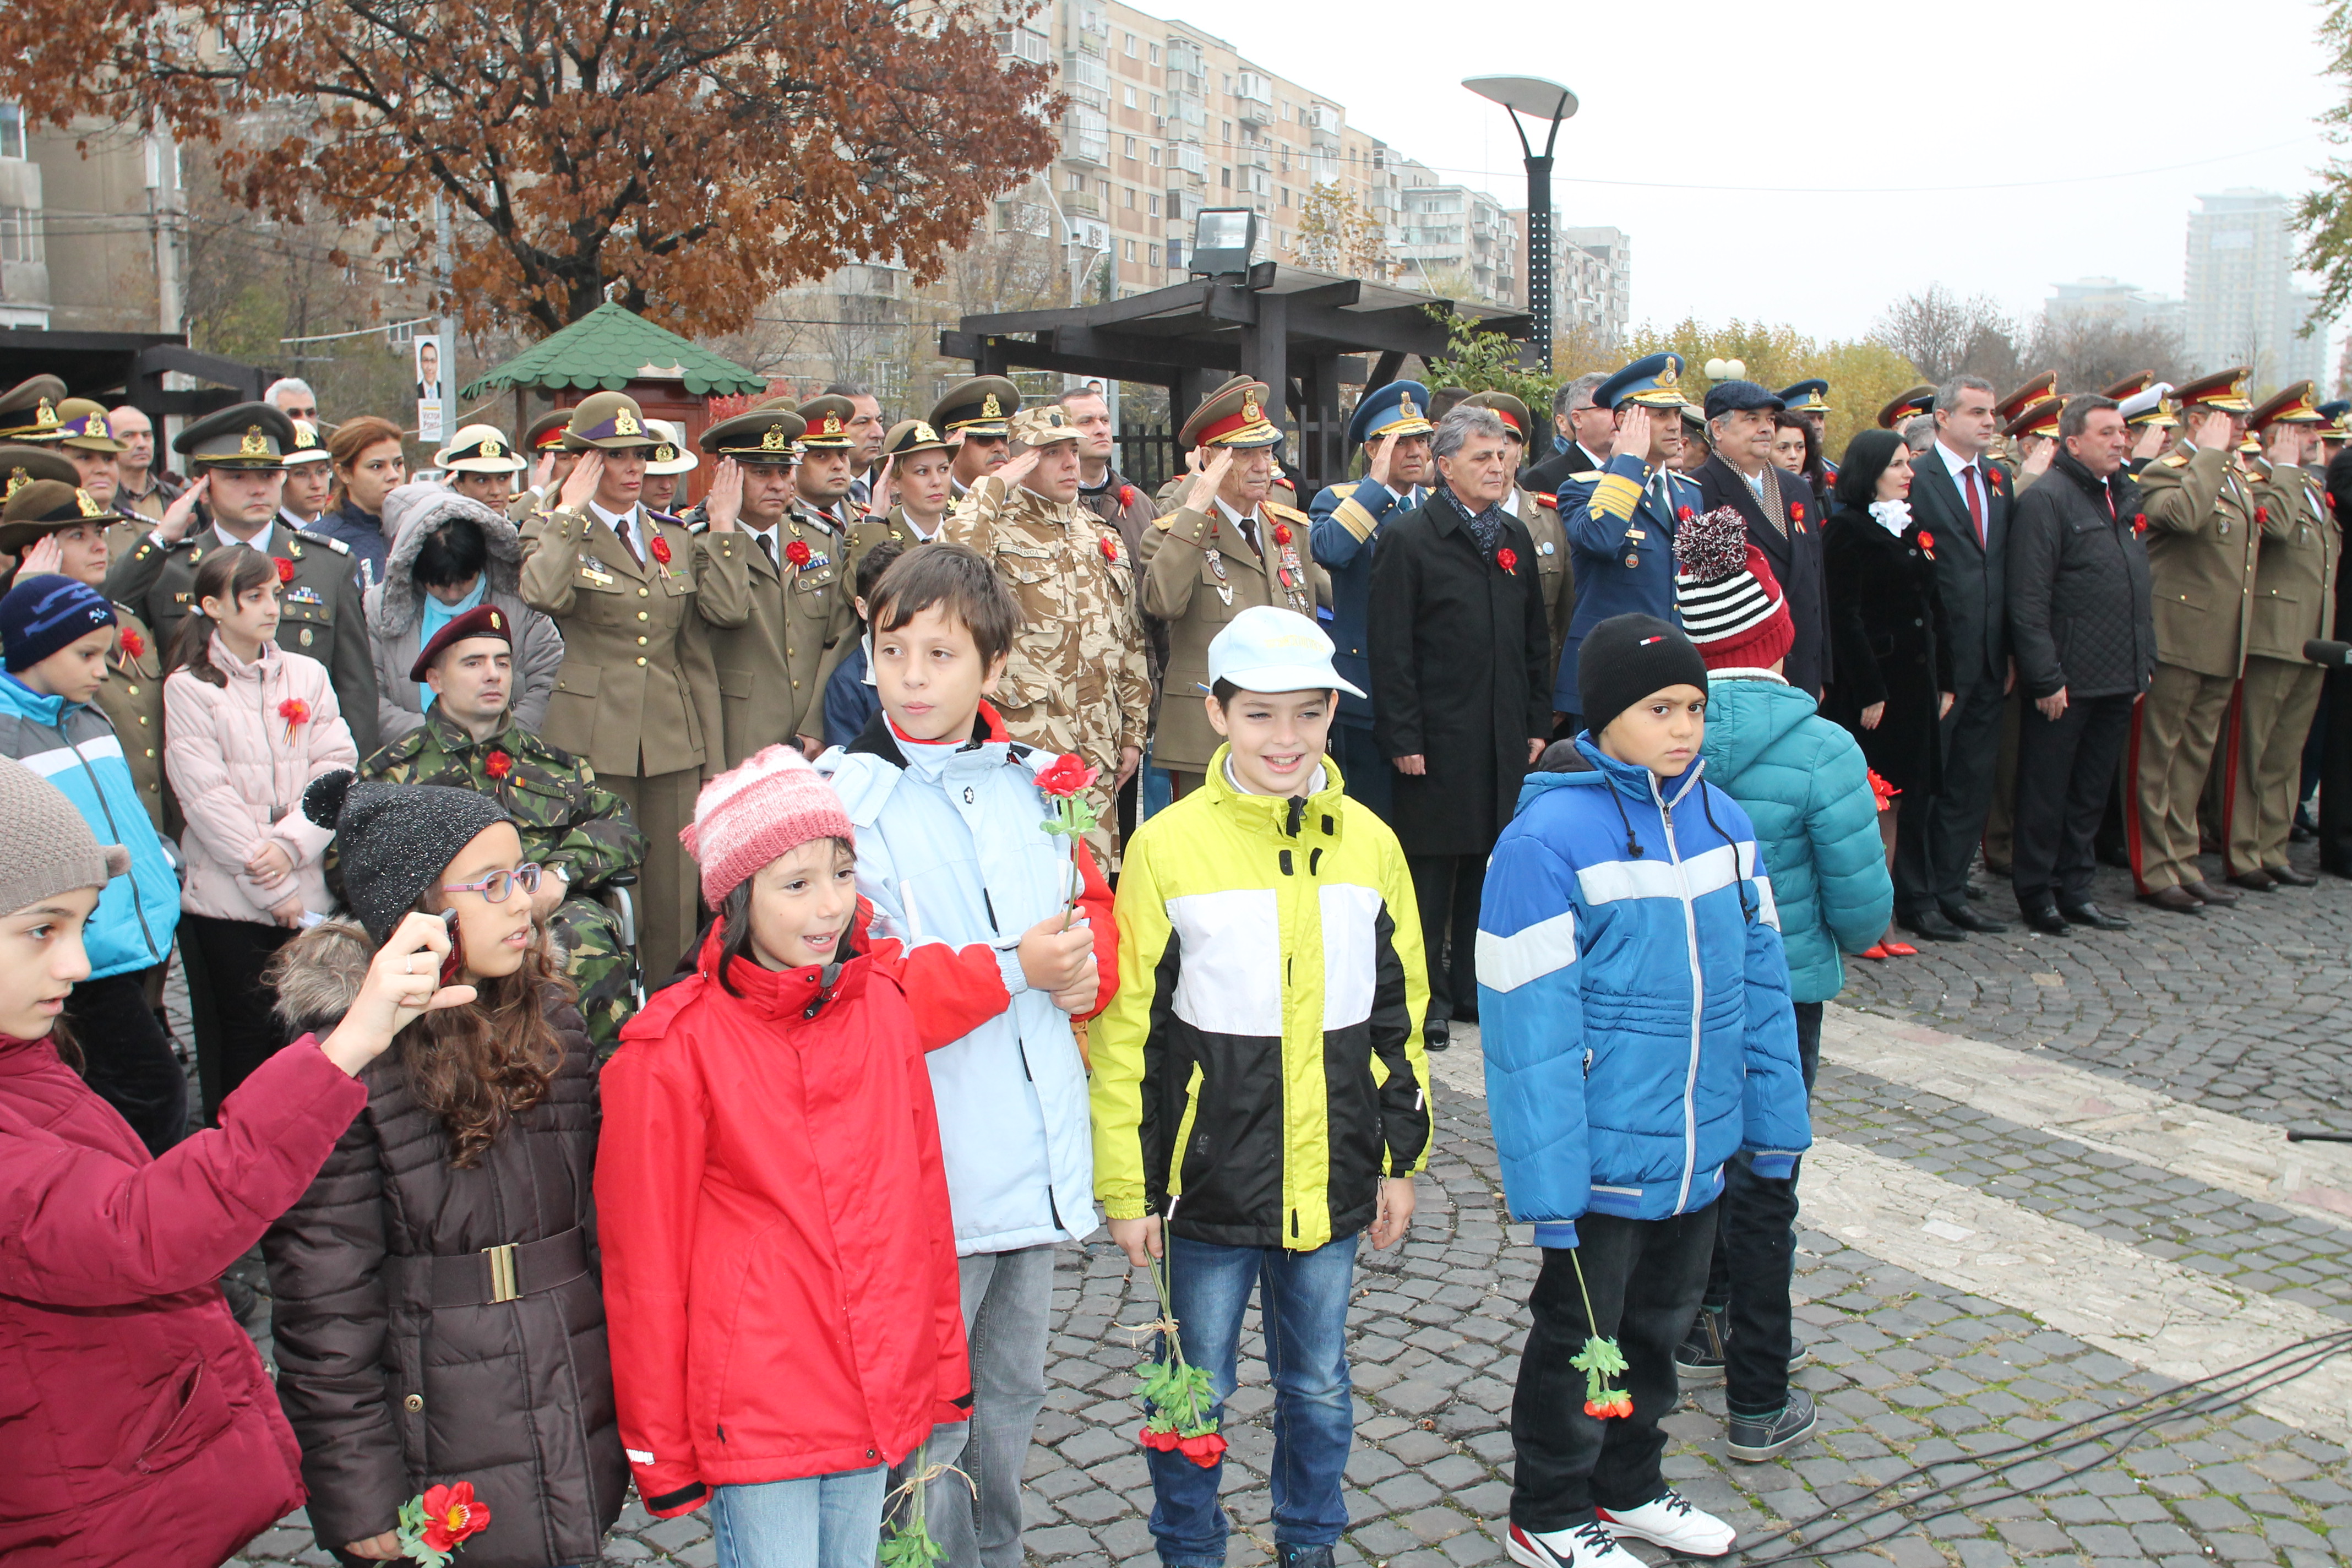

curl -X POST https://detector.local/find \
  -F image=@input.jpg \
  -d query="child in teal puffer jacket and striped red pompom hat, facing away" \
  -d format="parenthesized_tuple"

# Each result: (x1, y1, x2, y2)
(1675, 508, 1893, 1462)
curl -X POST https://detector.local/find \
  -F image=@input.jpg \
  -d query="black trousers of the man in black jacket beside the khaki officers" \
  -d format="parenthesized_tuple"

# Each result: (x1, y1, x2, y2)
(2008, 694, 2131, 910)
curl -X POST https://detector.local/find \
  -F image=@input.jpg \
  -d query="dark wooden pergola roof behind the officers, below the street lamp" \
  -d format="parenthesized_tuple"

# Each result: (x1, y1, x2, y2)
(939, 261, 1529, 496)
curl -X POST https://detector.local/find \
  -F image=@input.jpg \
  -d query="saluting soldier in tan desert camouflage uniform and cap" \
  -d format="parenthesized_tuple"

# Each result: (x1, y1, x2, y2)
(939, 402, 1152, 846)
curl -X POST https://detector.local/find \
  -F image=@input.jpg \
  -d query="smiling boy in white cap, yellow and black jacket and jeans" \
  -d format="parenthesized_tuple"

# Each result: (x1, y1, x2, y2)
(1091, 604, 1430, 1568)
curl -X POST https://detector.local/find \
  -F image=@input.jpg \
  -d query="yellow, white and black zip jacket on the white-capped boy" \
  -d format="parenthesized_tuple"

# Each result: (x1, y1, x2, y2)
(1091, 748, 1430, 1251)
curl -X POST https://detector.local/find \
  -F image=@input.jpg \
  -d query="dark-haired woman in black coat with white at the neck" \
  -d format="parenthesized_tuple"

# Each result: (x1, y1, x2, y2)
(1821, 430, 1952, 957)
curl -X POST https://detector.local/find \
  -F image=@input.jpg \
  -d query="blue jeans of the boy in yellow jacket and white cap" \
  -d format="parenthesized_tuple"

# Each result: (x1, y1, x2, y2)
(1145, 1237, 1357, 1568)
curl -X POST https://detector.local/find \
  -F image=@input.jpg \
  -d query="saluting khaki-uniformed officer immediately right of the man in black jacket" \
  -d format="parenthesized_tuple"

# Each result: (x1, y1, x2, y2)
(2124, 364, 2263, 914)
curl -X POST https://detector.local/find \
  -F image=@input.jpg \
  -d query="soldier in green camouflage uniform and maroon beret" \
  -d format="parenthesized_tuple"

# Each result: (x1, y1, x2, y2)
(360, 604, 645, 1055)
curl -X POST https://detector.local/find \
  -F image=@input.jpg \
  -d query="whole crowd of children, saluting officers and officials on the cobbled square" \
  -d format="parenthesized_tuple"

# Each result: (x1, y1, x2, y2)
(0, 352, 2352, 1568)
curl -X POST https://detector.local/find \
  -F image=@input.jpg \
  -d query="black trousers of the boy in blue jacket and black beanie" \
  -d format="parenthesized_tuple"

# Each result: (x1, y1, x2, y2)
(1510, 1204, 1719, 1533)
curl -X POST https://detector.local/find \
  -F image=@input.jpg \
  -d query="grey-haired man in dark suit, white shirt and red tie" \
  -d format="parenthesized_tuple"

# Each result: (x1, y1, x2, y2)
(1896, 376, 2016, 943)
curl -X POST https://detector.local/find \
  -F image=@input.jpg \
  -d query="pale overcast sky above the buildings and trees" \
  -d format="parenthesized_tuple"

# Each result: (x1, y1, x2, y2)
(1169, 0, 2340, 362)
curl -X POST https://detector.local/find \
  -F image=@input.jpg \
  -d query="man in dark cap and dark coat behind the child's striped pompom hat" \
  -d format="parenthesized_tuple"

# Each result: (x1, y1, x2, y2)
(1691, 381, 1830, 700)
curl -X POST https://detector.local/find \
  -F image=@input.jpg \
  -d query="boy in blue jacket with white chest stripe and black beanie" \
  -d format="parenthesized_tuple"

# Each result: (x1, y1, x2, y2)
(1477, 616, 1811, 1568)
